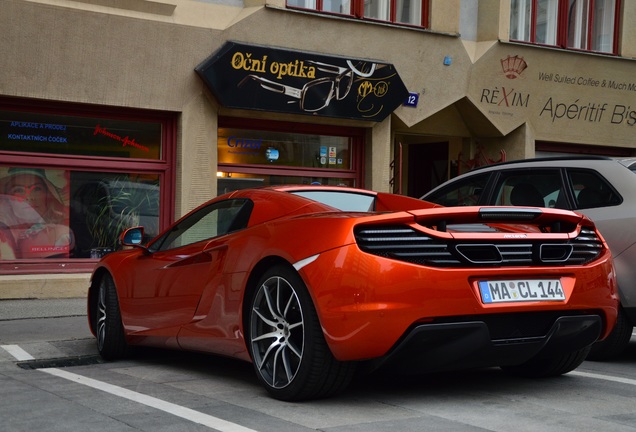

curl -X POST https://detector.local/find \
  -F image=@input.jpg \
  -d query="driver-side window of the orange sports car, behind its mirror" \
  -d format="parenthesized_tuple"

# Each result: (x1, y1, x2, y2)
(150, 199, 253, 252)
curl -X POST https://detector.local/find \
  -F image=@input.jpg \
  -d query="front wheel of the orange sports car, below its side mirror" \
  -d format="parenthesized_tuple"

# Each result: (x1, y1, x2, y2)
(95, 275, 128, 360)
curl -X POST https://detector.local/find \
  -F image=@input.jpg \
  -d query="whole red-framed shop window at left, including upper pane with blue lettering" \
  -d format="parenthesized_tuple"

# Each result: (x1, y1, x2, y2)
(0, 101, 174, 274)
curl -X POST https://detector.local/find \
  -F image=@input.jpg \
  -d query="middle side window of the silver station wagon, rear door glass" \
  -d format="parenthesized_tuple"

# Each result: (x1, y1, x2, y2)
(489, 169, 568, 209)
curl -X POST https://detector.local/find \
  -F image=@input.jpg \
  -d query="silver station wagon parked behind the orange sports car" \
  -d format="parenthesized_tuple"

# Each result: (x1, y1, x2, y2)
(422, 156, 636, 360)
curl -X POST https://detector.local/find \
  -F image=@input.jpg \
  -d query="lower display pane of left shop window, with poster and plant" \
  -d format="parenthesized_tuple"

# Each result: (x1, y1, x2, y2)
(0, 166, 159, 260)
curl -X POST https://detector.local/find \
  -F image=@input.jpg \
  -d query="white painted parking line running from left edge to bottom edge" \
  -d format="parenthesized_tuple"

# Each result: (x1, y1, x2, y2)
(2, 345, 256, 432)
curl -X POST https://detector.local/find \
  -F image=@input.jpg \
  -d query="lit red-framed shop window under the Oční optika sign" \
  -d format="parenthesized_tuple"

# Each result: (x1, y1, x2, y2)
(217, 118, 363, 194)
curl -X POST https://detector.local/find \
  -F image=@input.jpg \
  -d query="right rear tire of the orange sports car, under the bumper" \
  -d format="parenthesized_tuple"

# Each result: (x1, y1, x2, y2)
(501, 347, 590, 378)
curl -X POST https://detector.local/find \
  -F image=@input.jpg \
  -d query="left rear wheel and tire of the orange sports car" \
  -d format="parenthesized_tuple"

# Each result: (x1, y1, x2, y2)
(246, 265, 355, 401)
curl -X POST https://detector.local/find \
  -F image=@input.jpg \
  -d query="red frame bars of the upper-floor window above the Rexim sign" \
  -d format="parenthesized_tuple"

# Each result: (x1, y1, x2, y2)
(509, 0, 622, 55)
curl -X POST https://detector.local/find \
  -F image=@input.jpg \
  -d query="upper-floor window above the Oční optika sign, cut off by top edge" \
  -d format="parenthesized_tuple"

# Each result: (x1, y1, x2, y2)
(287, 0, 429, 27)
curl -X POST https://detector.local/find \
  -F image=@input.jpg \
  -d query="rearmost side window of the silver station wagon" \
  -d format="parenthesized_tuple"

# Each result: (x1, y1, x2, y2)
(567, 169, 622, 209)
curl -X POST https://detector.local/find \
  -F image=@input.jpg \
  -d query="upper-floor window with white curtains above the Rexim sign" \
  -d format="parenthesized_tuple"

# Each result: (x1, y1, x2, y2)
(510, 0, 621, 54)
